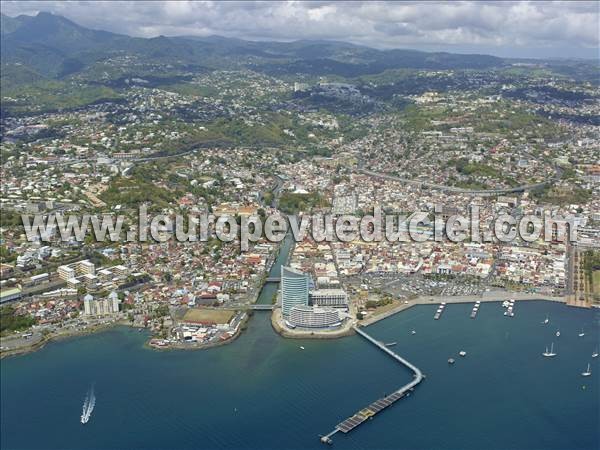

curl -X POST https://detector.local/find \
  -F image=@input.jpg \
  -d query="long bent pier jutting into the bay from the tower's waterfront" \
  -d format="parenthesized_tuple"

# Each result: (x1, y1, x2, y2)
(321, 325, 423, 444)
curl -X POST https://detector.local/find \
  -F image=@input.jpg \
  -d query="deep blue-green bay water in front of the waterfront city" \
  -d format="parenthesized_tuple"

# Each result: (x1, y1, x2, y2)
(0, 301, 600, 450)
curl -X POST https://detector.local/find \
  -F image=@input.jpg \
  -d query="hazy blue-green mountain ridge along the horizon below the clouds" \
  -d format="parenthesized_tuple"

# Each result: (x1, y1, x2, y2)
(1, 12, 504, 78)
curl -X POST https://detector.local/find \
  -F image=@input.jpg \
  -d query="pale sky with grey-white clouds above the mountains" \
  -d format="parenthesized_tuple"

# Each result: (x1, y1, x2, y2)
(1, 0, 600, 58)
